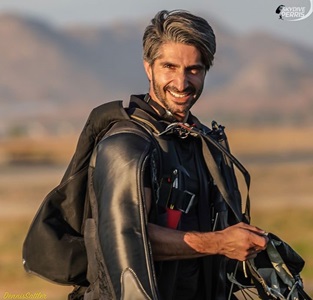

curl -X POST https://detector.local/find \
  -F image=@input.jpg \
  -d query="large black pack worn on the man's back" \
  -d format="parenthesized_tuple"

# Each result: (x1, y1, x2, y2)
(23, 101, 130, 286)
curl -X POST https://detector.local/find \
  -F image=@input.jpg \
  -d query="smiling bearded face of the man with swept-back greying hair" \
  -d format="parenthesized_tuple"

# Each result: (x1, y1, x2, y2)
(144, 42, 206, 121)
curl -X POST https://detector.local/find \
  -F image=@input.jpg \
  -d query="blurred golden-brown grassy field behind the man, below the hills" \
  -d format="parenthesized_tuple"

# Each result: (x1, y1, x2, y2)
(0, 128, 313, 300)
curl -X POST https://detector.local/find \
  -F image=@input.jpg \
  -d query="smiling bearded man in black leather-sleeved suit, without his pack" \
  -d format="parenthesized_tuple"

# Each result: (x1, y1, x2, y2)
(85, 11, 267, 300)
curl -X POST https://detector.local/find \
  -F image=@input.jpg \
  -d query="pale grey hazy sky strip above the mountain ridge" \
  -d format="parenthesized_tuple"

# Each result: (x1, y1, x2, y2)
(0, 0, 313, 47)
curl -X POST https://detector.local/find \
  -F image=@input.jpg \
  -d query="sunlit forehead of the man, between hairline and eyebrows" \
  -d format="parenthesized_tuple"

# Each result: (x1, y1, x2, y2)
(156, 42, 203, 66)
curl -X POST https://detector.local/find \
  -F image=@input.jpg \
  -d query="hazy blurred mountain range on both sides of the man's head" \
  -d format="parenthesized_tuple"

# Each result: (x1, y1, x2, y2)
(0, 15, 313, 133)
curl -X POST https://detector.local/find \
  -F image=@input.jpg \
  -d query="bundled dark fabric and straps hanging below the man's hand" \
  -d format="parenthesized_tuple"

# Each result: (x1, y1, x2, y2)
(228, 233, 311, 300)
